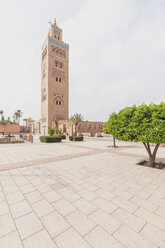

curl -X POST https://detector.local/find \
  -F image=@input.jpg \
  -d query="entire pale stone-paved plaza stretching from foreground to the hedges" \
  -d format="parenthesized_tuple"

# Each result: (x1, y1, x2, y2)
(0, 137, 165, 248)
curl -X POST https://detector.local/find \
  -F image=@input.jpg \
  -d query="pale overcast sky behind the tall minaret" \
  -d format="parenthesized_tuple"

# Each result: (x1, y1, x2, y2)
(0, 0, 165, 121)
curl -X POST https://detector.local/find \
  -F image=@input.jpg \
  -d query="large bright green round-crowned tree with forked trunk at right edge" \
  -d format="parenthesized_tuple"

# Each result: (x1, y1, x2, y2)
(106, 103, 165, 167)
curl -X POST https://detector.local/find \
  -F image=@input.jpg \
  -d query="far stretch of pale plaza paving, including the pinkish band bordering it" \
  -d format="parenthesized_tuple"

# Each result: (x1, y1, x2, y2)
(0, 137, 165, 170)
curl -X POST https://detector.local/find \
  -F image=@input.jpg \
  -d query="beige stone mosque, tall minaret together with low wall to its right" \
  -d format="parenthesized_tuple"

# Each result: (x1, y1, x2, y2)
(41, 20, 104, 136)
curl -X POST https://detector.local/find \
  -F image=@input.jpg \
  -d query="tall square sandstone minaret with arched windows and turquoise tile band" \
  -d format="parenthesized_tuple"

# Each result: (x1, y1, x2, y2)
(41, 19, 69, 134)
